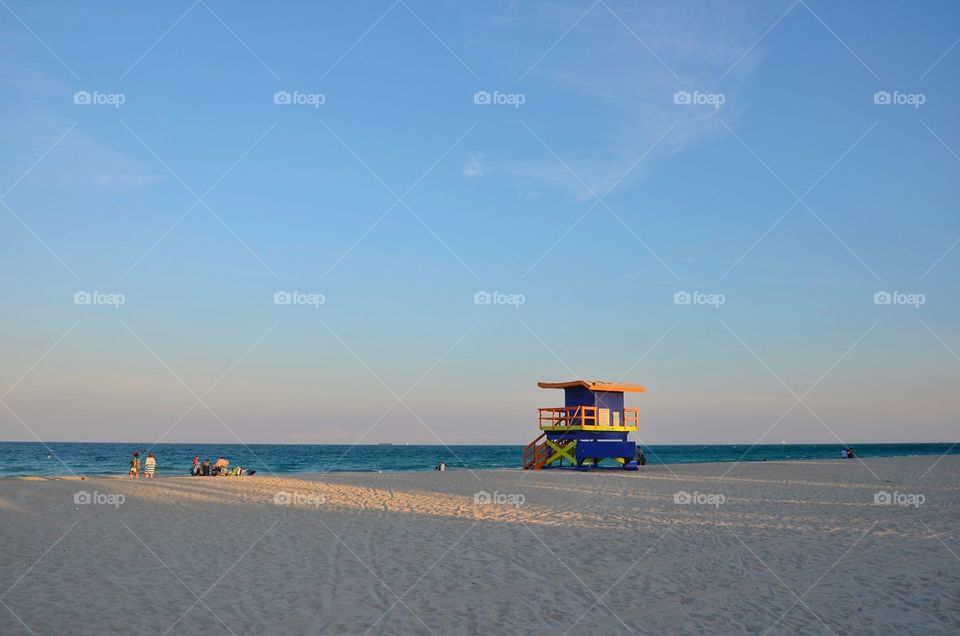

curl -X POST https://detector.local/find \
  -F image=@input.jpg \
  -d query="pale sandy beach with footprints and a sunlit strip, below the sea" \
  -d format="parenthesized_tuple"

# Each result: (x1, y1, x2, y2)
(0, 456, 960, 635)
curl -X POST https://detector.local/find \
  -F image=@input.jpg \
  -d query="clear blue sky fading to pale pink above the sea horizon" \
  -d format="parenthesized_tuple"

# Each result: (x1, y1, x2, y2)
(0, 0, 960, 444)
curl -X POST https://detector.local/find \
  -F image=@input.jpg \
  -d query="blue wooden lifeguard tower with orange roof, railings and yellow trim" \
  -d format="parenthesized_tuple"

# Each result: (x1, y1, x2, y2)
(523, 380, 646, 470)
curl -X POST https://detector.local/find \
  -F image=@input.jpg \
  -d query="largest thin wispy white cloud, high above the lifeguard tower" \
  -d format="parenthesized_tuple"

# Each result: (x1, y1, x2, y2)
(476, 2, 789, 200)
